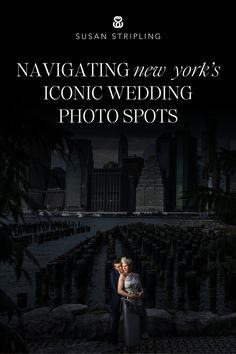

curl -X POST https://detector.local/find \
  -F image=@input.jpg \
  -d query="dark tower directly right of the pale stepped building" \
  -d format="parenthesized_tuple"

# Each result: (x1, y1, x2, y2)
(156, 134, 176, 211)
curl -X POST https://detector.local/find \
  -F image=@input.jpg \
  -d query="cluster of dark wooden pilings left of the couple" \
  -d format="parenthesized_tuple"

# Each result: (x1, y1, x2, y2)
(17, 231, 103, 308)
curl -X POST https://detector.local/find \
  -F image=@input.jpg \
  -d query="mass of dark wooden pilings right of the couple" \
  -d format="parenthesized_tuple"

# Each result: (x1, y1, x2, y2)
(115, 224, 236, 308)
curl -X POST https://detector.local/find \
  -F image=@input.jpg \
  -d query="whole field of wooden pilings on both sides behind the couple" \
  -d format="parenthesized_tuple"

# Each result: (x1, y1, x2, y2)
(17, 223, 236, 309)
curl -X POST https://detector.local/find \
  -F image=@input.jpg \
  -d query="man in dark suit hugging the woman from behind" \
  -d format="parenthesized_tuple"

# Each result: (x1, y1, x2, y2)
(110, 259, 123, 345)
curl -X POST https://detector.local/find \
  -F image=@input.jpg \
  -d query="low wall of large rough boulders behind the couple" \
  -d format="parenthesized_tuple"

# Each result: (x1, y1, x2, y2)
(0, 304, 236, 340)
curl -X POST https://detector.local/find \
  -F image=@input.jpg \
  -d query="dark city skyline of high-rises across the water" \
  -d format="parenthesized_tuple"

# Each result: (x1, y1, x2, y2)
(43, 129, 235, 213)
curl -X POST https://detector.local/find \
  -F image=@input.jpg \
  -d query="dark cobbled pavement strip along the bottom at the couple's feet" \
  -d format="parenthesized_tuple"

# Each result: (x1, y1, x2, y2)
(29, 336, 236, 354)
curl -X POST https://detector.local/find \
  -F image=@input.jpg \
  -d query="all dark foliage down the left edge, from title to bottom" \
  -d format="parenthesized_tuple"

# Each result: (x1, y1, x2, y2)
(0, 112, 72, 352)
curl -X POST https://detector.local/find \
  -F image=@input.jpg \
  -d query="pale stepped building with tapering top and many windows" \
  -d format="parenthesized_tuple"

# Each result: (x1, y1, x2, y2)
(136, 156, 164, 213)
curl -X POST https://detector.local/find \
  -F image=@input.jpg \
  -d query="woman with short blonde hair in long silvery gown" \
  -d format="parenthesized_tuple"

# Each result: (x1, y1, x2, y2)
(118, 257, 147, 347)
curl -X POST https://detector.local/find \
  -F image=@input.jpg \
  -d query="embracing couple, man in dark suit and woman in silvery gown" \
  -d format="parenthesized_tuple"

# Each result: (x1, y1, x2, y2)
(110, 257, 147, 347)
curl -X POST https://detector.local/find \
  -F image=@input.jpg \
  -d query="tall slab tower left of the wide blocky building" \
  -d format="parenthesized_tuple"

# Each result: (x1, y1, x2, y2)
(65, 140, 93, 211)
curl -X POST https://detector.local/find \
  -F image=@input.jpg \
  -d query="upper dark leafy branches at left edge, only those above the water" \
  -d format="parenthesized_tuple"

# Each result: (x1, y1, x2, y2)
(0, 115, 72, 222)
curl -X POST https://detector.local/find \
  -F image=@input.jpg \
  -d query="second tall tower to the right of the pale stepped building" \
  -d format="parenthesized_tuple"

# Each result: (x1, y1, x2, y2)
(176, 131, 197, 211)
